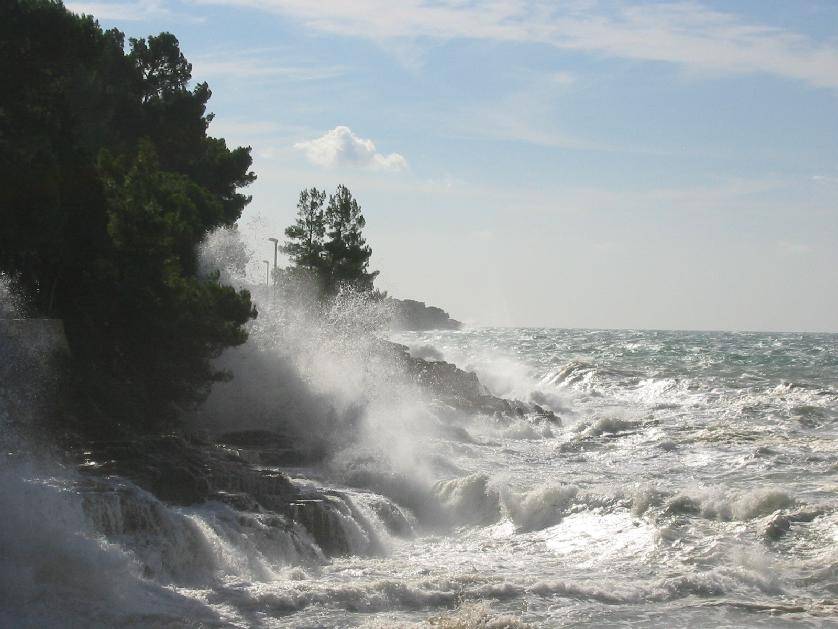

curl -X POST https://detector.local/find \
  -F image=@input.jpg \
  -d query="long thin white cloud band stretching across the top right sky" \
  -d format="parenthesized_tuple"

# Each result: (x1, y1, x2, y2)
(194, 0, 838, 88)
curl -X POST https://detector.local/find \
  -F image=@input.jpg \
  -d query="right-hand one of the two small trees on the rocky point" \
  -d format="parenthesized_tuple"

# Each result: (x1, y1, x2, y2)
(324, 185, 378, 293)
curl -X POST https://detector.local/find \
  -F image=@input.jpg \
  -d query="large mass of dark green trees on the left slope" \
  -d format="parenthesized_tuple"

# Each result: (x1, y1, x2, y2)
(0, 0, 256, 423)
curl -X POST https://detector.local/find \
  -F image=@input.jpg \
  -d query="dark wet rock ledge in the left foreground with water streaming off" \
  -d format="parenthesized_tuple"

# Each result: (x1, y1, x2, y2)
(78, 431, 398, 556)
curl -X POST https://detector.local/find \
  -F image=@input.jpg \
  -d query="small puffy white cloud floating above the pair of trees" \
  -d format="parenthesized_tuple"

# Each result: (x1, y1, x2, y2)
(294, 126, 407, 171)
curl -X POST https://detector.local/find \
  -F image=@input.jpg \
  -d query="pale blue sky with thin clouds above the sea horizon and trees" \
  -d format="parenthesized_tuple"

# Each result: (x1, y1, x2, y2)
(65, 0, 838, 332)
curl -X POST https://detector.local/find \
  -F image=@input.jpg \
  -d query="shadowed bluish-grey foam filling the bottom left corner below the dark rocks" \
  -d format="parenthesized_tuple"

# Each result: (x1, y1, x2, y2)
(0, 460, 223, 627)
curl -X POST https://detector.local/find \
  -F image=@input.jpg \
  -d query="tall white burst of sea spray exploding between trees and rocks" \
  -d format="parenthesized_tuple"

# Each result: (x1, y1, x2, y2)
(199, 232, 480, 519)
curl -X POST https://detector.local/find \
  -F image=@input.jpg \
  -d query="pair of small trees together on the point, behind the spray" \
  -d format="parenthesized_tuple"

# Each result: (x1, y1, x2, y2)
(283, 186, 378, 296)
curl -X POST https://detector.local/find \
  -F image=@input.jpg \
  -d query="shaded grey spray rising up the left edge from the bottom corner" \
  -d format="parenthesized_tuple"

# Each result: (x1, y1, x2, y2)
(0, 282, 216, 627)
